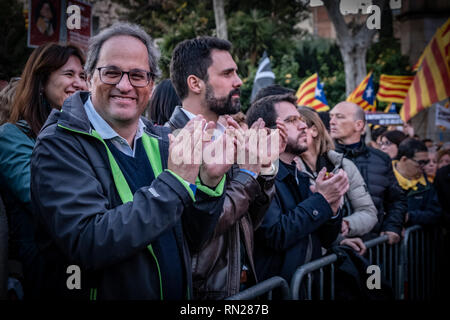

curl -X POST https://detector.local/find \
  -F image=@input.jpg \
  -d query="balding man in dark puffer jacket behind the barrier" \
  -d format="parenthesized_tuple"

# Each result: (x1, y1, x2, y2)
(330, 101, 407, 244)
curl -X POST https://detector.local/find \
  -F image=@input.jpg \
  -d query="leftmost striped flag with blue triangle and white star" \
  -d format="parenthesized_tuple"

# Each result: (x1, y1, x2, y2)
(295, 73, 330, 111)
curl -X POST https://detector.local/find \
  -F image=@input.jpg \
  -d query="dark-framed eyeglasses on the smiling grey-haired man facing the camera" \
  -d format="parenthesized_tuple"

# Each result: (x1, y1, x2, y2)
(97, 66, 155, 87)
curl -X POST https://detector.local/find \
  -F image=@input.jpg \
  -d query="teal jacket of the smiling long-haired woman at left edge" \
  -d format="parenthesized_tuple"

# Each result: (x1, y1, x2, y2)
(0, 120, 42, 299)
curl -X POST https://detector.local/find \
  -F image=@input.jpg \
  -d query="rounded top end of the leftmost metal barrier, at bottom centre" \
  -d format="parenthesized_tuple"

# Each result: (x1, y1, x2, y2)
(225, 276, 291, 300)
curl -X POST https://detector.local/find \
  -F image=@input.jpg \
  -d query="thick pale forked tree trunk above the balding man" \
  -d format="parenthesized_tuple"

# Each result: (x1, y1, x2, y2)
(322, 0, 386, 96)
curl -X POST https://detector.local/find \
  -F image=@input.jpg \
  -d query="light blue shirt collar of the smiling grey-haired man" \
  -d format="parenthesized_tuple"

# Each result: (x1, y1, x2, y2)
(84, 97, 145, 157)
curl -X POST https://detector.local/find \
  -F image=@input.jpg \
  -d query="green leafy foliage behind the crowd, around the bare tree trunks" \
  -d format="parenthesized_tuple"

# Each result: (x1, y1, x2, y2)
(114, 0, 410, 111)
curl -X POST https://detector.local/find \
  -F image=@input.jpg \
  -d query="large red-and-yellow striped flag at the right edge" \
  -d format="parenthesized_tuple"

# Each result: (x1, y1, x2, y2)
(400, 19, 450, 122)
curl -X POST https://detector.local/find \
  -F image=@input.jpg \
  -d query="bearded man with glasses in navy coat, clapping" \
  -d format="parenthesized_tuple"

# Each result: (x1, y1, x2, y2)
(247, 93, 348, 282)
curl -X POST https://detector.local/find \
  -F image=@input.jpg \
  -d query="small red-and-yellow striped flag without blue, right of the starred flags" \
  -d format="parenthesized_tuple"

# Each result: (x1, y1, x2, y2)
(377, 74, 414, 104)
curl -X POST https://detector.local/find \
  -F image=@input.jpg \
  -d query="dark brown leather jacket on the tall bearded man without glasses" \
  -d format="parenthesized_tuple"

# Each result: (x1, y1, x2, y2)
(166, 107, 275, 299)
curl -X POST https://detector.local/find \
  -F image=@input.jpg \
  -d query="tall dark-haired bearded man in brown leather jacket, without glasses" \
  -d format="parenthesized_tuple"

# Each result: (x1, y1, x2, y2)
(166, 37, 284, 299)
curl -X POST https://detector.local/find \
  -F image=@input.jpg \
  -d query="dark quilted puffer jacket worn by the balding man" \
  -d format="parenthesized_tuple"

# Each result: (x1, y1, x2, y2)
(336, 139, 407, 235)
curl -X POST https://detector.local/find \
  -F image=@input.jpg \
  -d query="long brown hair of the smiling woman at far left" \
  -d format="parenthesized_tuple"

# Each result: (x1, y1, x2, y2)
(9, 43, 85, 137)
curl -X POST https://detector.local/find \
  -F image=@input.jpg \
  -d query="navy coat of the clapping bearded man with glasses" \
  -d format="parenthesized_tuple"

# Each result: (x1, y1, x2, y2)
(255, 161, 342, 281)
